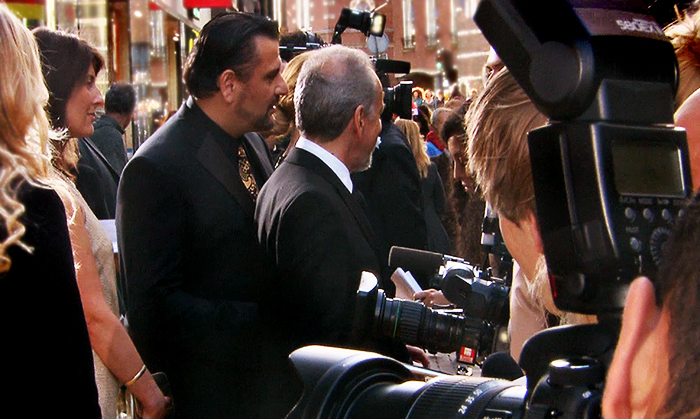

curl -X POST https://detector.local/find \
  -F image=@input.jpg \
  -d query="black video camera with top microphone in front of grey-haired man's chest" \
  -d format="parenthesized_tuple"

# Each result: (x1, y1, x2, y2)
(354, 246, 509, 364)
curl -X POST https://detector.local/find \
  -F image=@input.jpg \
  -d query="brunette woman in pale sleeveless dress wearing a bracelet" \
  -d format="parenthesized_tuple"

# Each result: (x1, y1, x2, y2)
(34, 28, 169, 418)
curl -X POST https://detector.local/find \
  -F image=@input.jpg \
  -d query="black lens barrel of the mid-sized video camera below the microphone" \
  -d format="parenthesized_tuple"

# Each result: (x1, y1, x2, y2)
(375, 292, 483, 353)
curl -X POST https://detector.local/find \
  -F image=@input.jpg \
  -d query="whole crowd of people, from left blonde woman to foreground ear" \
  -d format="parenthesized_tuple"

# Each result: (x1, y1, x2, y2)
(0, 4, 700, 419)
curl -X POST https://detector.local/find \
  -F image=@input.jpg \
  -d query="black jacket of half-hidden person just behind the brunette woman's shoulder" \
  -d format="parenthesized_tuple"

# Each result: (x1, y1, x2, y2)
(76, 137, 119, 220)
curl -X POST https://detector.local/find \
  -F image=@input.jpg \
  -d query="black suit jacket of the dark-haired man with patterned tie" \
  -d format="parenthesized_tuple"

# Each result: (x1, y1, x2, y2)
(116, 98, 272, 418)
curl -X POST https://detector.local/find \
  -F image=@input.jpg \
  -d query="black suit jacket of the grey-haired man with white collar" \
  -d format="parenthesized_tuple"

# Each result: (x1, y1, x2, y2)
(255, 148, 405, 416)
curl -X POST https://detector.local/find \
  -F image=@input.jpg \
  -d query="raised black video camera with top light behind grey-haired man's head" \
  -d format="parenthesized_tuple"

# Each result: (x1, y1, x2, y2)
(331, 6, 413, 120)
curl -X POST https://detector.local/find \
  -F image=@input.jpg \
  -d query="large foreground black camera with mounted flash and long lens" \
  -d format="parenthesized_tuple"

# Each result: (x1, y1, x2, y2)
(282, 0, 692, 418)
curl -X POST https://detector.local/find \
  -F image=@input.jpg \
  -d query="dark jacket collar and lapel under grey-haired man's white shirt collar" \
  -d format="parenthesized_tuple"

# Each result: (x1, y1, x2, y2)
(284, 147, 375, 246)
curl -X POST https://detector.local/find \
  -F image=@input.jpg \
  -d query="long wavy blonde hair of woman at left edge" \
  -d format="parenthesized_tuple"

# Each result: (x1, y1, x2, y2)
(0, 3, 60, 273)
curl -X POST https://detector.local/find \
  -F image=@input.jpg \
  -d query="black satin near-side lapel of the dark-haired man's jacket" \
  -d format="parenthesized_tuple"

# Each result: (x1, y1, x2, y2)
(197, 134, 255, 217)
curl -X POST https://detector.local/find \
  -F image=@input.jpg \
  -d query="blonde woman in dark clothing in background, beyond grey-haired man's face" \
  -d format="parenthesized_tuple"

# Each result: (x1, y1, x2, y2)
(394, 118, 452, 254)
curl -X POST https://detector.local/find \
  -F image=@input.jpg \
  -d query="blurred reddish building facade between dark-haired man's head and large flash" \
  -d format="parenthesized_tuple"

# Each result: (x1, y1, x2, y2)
(273, 0, 489, 95)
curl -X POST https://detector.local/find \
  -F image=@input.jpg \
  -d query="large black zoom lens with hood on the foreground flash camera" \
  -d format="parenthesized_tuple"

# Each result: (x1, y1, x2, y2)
(287, 346, 526, 419)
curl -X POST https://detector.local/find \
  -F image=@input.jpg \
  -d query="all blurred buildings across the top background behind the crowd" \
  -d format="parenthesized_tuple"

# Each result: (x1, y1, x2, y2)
(8, 0, 682, 151)
